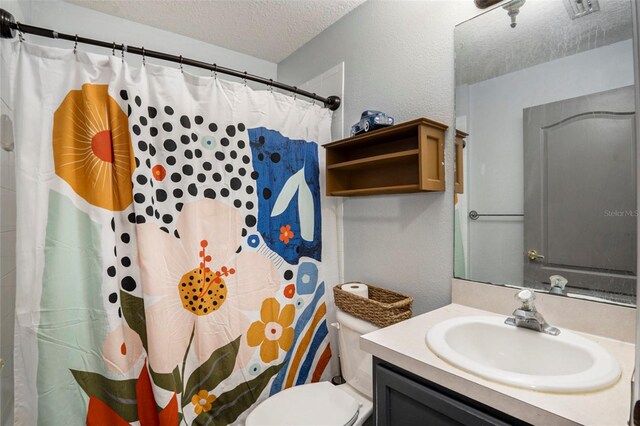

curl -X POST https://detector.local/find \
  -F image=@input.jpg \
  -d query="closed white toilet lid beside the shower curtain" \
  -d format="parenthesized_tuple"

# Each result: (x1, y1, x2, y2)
(246, 382, 359, 426)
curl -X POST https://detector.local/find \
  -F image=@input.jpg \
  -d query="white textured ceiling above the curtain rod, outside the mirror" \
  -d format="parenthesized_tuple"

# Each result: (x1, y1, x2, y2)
(65, 0, 365, 63)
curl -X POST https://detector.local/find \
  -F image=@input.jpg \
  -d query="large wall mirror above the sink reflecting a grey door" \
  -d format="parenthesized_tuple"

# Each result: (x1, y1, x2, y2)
(455, 0, 637, 304)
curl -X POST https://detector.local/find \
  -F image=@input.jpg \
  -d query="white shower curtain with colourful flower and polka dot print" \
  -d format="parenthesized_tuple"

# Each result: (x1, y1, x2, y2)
(6, 41, 338, 426)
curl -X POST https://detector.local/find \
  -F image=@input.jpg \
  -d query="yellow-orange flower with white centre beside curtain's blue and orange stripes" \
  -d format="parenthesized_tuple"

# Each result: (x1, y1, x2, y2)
(247, 297, 296, 363)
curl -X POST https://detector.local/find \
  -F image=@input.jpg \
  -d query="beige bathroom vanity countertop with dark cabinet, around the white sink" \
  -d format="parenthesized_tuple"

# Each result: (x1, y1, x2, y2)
(360, 280, 635, 425)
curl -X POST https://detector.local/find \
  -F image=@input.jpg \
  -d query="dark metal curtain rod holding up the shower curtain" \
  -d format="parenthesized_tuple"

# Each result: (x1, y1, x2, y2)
(0, 9, 341, 111)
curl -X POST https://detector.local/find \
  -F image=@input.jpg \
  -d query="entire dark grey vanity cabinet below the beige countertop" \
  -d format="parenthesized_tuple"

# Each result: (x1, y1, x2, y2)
(373, 358, 527, 426)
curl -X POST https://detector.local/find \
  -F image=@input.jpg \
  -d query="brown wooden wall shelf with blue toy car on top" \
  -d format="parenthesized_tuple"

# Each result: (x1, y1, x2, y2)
(324, 118, 447, 196)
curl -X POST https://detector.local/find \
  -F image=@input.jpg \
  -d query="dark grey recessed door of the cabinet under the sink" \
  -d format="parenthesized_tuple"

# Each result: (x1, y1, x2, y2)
(375, 365, 508, 426)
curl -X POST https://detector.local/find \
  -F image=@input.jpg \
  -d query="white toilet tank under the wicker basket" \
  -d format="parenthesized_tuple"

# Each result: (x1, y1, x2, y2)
(336, 309, 380, 399)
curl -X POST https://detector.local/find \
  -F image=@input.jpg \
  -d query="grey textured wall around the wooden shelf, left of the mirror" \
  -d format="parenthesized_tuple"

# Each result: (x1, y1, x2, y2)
(278, 0, 479, 314)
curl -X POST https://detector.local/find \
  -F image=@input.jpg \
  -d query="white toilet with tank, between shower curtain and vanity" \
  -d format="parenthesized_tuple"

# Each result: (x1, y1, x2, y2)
(246, 309, 379, 426)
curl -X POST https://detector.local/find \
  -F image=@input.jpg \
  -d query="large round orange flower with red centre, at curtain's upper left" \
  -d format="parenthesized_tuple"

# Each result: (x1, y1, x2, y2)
(53, 84, 135, 211)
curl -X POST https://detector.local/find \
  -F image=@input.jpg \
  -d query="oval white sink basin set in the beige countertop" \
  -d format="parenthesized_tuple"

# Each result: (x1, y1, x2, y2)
(426, 316, 621, 393)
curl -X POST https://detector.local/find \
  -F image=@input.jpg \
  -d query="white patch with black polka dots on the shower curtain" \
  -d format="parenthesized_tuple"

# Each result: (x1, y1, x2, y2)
(120, 93, 260, 282)
